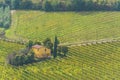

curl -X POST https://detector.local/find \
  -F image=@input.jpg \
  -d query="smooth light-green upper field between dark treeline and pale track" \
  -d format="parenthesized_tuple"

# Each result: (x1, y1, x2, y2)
(6, 11, 120, 43)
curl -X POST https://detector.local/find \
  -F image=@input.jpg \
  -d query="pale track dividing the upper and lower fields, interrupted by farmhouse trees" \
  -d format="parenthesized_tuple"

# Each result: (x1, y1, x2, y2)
(0, 37, 120, 47)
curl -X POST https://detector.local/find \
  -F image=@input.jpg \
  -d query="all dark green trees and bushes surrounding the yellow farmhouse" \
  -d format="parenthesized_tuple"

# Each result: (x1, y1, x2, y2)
(7, 36, 68, 66)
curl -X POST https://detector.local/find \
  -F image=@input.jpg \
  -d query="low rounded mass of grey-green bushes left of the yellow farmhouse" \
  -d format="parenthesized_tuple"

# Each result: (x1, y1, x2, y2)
(7, 49, 34, 66)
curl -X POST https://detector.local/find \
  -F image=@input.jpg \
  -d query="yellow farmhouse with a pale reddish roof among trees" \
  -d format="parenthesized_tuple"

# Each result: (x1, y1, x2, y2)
(32, 45, 51, 58)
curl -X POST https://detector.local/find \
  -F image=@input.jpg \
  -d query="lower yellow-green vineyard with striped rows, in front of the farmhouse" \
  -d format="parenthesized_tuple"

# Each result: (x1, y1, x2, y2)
(0, 41, 120, 80)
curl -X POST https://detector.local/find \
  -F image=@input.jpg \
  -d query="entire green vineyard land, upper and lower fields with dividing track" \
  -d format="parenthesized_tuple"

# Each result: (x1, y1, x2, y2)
(0, 7, 120, 80)
